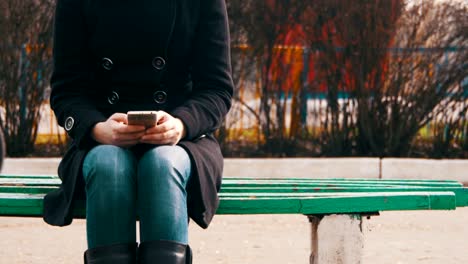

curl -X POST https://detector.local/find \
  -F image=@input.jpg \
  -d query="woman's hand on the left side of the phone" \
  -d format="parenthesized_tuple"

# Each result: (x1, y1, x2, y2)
(91, 113, 145, 147)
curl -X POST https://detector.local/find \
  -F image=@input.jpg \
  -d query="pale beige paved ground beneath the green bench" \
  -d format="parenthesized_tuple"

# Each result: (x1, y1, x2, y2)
(0, 160, 468, 264)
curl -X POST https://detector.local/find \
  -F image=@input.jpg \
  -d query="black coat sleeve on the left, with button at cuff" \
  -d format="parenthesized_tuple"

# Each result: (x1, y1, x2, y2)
(50, 0, 106, 147)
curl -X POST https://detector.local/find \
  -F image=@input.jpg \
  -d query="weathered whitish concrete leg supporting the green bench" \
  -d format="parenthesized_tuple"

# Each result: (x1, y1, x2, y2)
(308, 215, 364, 264)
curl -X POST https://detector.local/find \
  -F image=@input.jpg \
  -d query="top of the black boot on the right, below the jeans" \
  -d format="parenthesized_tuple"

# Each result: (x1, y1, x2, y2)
(138, 240, 192, 264)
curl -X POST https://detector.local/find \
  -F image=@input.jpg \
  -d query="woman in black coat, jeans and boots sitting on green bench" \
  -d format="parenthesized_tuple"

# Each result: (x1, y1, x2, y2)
(44, 0, 233, 264)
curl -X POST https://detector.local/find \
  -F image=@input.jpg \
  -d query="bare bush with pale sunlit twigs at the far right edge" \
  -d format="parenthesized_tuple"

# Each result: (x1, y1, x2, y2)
(384, 0, 468, 157)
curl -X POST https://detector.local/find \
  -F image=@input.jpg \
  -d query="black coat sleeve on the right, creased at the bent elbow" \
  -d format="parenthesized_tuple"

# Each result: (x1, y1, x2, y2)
(172, 0, 234, 140)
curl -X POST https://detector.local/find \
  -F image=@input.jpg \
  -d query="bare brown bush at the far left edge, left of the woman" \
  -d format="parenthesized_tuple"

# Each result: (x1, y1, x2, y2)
(0, 0, 55, 156)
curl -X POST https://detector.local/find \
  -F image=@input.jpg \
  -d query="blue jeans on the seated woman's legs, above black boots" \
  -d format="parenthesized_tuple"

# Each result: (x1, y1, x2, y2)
(83, 145, 191, 248)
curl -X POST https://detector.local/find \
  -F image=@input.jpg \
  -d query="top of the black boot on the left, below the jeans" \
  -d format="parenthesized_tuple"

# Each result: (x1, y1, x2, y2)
(84, 243, 137, 264)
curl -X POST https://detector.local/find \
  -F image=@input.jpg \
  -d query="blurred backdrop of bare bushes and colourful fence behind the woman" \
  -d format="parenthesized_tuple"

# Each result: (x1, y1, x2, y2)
(0, 0, 468, 158)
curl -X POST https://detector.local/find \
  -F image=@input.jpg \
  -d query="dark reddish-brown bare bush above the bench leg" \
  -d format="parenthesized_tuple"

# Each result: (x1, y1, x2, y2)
(304, 0, 404, 156)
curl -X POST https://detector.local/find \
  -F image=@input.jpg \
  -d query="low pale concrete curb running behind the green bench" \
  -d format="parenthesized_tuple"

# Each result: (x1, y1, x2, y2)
(2, 158, 468, 184)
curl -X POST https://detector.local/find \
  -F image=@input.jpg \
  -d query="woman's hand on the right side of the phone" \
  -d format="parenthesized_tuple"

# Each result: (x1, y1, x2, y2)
(140, 111, 185, 145)
